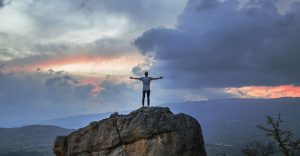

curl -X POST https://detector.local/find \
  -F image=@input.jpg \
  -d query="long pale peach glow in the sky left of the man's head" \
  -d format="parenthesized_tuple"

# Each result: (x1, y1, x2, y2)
(30, 55, 142, 76)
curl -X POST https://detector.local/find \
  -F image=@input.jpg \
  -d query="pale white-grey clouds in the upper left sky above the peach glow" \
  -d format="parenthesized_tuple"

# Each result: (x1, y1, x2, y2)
(0, 0, 186, 74)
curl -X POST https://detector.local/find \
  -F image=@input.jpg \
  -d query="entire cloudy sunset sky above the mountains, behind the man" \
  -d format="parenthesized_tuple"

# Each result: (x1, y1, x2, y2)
(0, 0, 300, 127)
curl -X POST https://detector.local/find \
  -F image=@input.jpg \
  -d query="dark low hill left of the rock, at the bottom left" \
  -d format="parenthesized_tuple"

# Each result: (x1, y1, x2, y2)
(0, 125, 74, 156)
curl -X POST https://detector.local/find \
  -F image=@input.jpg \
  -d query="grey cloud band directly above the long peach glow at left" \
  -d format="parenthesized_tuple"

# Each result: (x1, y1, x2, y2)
(0, 39, 135, 66)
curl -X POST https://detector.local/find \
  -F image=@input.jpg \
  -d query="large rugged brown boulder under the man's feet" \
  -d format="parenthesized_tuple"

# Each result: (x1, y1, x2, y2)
(53, 107, 206, 156)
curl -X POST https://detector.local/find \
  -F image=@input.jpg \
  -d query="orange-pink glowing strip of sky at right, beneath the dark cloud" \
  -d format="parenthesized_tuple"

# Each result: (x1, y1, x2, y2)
(225, 85, 300, 98)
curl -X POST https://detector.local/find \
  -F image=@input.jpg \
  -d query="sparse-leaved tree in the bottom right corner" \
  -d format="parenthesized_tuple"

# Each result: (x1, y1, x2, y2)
(257, 114, 300, 156)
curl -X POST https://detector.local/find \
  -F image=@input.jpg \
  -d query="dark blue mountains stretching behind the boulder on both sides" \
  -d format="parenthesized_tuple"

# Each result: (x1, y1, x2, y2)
(0, 98, 300, 155)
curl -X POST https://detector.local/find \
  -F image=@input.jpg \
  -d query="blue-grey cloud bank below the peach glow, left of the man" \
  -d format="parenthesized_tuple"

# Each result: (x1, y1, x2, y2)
(0, 69, 140, 127)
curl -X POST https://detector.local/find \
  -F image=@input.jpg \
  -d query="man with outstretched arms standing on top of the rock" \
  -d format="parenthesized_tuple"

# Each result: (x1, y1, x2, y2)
(129, 71, 164, 107)
